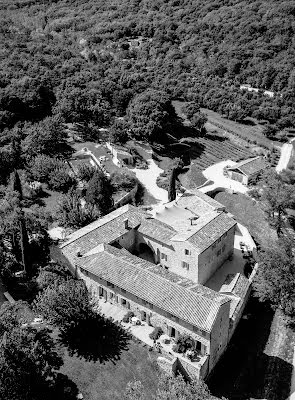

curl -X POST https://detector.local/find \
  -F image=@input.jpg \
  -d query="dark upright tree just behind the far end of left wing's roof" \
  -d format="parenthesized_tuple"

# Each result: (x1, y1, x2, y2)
(85, 171, 114, 215)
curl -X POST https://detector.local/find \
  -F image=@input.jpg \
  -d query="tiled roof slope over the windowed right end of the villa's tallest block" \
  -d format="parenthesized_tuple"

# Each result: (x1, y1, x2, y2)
(188, 212, 236, 253)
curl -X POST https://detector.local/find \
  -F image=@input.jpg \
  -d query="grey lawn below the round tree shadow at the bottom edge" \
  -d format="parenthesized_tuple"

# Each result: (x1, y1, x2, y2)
(61, 338, 158, 400)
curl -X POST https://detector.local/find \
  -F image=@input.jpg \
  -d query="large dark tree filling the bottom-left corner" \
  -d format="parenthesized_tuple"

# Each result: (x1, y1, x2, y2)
(0, 328, 63, 400)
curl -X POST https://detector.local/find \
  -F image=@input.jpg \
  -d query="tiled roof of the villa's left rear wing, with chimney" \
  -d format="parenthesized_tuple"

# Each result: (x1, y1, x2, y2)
(60, 204, 147, 264)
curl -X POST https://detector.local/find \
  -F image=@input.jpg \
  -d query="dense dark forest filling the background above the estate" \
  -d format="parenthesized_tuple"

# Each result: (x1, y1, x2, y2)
(0, 0, 295, 181)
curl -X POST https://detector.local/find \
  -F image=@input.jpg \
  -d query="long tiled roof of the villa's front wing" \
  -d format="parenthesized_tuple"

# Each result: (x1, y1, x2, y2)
(79, 245, 229, 332)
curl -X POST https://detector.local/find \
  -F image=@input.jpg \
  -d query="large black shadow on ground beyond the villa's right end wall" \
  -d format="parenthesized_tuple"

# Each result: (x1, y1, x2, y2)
(208, 298, 292, 400)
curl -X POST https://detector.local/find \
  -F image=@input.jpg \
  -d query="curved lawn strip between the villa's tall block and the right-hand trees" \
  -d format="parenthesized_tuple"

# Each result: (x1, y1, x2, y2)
(215, 192, 277, 247)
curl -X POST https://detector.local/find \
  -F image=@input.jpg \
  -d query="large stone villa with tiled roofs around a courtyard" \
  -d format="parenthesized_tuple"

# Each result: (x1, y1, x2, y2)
(60, 190, 250, 378)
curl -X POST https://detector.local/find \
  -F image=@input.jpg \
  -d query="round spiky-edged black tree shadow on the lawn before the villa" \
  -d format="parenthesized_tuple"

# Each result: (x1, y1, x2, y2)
(59, 313, 131, 363)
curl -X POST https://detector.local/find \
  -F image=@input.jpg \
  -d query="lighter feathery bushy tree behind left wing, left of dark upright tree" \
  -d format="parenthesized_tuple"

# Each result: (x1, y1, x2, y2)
(57, 190, 100, 228)
